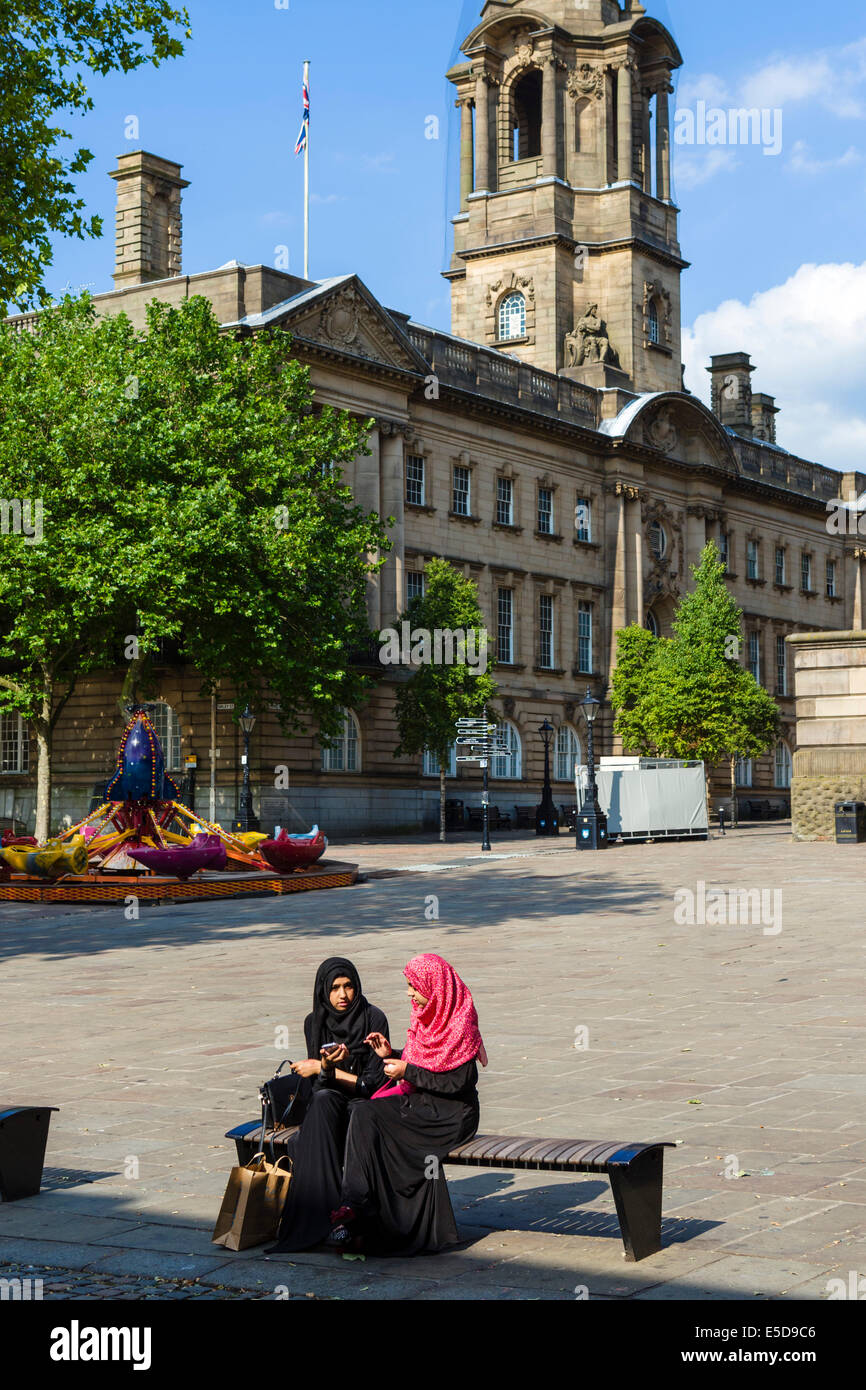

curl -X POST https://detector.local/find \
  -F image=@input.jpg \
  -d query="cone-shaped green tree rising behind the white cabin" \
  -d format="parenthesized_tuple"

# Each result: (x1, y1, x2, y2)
(612, 541, 778, 805)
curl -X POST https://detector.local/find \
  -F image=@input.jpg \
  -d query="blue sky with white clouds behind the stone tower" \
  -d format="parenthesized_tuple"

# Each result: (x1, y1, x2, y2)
(49, 0, 866, 471)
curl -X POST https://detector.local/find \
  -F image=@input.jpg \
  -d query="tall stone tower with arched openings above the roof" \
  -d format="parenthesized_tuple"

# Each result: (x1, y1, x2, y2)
(446, 0, 687, 392)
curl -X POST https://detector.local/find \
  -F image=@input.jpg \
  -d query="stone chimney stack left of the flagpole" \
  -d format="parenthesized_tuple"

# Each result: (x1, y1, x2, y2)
(111, 150, 189, 289)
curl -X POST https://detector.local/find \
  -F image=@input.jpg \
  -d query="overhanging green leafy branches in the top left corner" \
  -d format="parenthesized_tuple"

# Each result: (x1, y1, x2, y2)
(0, 0, 190, 316)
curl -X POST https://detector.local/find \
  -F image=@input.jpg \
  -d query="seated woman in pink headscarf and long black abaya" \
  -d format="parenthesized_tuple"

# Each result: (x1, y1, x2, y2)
(328, 955, 487, 1254)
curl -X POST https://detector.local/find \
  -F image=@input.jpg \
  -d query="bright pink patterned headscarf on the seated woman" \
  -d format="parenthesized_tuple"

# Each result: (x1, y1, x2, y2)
(403, 955, 487, 1072)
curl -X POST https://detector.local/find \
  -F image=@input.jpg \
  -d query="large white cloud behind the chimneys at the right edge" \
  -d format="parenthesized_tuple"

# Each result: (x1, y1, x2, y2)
(683, 261, 866, 471)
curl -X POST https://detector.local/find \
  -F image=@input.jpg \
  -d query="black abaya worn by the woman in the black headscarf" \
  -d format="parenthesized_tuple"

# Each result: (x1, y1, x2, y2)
(274, 1005, 388, 1254)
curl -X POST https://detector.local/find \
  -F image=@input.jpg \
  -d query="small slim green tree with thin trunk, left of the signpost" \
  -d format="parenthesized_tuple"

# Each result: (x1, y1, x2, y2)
(393, 560, 496, 840)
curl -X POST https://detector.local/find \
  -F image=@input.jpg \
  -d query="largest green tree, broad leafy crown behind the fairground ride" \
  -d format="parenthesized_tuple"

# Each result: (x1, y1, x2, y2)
(0, 296, 388, 838)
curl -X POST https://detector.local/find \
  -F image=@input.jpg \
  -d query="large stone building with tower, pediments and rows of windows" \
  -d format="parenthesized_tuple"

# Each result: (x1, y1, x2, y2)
(0, 0, 866, 834)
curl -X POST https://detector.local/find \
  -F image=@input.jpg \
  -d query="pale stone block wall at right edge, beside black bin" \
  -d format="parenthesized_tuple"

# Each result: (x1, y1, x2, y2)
(788, 631, 866, 840)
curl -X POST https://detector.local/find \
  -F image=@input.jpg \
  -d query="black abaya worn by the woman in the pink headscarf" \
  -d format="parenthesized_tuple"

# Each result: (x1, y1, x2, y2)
(341, 1062, 478, 1255)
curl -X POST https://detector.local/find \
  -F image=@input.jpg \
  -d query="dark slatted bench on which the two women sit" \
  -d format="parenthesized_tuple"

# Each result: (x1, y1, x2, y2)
(225, 1119, 674, 1261)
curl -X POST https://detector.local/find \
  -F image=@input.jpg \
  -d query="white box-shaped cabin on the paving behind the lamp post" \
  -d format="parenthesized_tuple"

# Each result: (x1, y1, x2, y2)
(574, 758, 709, 840)
